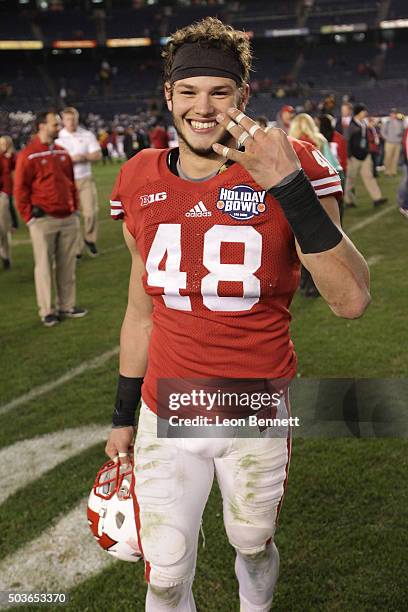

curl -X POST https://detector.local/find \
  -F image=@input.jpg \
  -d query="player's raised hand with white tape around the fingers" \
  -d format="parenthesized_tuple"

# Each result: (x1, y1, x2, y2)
(213, 108, 301, 190)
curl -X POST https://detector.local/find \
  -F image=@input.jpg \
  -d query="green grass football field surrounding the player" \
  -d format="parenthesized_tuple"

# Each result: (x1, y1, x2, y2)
(0, 165, 408, 612)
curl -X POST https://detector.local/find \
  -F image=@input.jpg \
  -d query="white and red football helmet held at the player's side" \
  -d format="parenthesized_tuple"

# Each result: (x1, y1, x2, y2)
(87, 449, 142, 561)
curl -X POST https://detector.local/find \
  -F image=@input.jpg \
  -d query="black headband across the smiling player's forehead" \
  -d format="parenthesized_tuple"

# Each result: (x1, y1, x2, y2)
(170, 43, 243, 85)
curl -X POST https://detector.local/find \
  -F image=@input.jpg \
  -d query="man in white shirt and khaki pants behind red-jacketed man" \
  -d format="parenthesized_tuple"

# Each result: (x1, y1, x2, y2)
(56, 106, 102, 259)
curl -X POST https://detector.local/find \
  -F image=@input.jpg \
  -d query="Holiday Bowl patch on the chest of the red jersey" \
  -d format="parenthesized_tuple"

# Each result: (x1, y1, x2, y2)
(217, 185, 266, 221)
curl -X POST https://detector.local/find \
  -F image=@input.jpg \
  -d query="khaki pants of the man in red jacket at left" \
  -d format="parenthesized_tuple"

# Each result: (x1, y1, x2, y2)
(29, 213, 80, 317)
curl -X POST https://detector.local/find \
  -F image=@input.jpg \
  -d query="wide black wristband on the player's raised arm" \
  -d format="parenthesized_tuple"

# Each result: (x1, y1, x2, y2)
(268, 170, 343, 254)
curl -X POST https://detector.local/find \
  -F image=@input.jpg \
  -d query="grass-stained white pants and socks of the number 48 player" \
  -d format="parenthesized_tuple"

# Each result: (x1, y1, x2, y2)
(135, 401, 290, 612)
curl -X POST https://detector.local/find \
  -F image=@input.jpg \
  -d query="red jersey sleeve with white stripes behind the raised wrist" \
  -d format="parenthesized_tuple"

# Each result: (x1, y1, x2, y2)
(292, 139, 343, 200)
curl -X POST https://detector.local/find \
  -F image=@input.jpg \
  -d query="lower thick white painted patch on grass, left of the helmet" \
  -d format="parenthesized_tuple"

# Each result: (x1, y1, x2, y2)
(0, 500, 113, 607)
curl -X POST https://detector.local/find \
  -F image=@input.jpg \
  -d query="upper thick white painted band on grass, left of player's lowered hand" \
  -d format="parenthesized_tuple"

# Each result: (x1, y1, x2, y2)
(0, 425, 109, 504)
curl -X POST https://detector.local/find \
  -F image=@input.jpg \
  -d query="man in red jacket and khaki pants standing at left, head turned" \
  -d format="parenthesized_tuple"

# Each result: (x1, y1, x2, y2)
(14, 112, 87, 327)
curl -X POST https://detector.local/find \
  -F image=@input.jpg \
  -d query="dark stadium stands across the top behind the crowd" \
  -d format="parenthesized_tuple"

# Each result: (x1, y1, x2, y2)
(0, 0, 408, 115)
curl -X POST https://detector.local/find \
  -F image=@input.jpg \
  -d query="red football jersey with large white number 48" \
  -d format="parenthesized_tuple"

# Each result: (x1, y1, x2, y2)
(111, 139, 341, 411)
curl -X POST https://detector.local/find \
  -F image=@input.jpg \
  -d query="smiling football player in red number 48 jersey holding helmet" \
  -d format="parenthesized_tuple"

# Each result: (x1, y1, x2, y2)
(106, 18, 370, 612)
